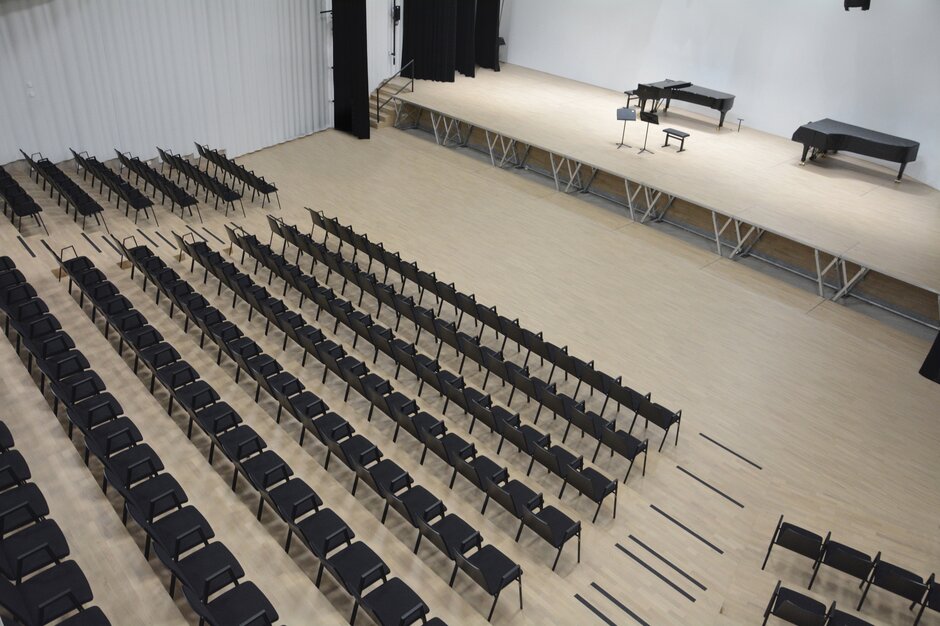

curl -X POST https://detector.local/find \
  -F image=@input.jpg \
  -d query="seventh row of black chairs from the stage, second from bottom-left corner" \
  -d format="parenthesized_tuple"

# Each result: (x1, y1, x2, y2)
(0, 255, 277, 625)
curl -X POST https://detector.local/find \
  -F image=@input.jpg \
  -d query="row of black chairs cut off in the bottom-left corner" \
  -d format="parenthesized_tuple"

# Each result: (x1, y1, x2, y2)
(0, 414, 111, 626)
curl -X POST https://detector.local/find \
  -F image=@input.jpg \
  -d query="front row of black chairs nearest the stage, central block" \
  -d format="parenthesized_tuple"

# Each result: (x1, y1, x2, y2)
(307, 208, 682, 450)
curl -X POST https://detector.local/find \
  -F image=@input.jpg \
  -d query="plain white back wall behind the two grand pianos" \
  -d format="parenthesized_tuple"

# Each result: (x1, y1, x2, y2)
(501, 0, 940, 187)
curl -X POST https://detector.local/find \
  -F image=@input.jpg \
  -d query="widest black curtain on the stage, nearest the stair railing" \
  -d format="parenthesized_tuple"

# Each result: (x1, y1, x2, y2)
(401, 0, 458, 83)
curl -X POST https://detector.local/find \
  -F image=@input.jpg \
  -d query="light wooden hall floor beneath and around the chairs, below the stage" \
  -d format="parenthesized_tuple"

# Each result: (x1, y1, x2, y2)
(0, 124, 940, 625)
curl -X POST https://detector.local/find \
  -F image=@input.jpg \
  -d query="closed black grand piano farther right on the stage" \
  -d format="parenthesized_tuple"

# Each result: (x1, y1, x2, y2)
(793, 118, 920, 183)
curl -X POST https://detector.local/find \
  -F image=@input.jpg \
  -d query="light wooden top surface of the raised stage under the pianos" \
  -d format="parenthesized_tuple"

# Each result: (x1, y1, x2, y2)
(398, 64, 940, 294)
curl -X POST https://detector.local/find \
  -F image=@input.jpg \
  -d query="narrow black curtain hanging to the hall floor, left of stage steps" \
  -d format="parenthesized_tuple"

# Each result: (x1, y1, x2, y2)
(333, 0, 369, 139)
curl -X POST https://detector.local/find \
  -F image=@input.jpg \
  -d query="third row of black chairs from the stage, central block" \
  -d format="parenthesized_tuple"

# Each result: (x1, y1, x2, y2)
(234, 226, 629, 521)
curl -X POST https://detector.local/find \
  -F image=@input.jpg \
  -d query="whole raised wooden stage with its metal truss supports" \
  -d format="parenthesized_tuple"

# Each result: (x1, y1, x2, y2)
(396, 64, 940, 325)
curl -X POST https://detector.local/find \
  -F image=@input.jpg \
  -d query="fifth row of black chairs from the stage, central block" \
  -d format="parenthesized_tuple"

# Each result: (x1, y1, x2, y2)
(114, 240, 532, 619)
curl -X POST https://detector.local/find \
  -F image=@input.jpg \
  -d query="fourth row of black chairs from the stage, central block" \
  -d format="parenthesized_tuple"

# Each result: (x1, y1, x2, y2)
(170, 233, 580, 568)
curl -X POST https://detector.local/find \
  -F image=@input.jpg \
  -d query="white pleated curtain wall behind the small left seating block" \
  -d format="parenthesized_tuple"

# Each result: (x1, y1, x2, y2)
(0, 0, 333, 163)
